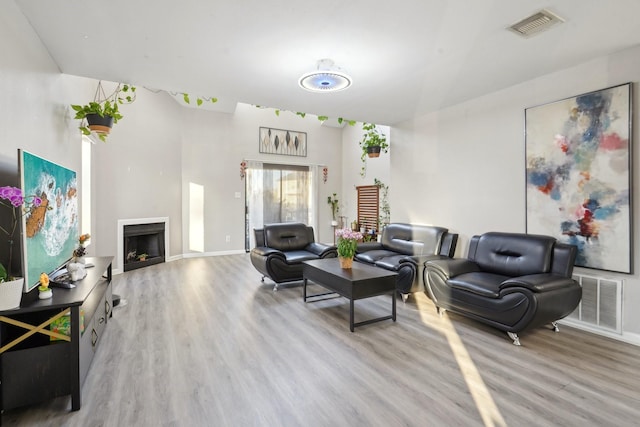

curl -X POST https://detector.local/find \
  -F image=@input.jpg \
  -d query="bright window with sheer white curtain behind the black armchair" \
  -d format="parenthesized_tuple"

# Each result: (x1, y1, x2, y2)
(245, 160, 318, 251)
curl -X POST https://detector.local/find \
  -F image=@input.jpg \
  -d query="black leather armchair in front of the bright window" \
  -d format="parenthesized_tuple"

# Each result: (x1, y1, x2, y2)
(250, 222, 337, 291)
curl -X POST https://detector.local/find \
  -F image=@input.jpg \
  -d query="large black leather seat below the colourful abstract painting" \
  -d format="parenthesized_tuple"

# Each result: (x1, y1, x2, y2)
(424, 232, 582, 345)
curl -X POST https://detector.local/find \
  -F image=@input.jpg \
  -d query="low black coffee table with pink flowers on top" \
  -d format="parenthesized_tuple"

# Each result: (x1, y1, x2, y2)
(302, 258, 398, 332)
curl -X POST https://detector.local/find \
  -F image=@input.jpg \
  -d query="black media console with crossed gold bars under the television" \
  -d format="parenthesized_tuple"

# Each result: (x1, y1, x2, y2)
(0, 257, 113, 414)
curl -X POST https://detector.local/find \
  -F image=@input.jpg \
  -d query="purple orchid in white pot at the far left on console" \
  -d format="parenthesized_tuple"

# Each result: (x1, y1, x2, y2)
(0, 186, 44, 302)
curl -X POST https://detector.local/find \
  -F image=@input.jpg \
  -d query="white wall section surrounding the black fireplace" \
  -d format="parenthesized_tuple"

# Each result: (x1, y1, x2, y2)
(89, 85, 182, 267)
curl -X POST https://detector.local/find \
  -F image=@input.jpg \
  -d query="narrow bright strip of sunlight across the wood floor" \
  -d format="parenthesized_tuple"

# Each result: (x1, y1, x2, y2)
(415, 295, 507, 427)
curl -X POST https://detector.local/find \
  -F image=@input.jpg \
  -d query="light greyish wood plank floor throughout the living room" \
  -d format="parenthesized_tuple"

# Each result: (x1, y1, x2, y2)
(2, 255, 640, 427)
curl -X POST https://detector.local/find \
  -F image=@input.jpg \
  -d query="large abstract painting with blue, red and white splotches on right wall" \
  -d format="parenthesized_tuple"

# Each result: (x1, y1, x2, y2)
(525, 83, 633, 273)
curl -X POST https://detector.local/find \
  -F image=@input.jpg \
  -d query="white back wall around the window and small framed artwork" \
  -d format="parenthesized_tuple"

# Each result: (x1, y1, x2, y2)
(182, 104, 342, 253)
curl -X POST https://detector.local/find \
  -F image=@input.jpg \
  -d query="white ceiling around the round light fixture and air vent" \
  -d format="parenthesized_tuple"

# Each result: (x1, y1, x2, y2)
(15, 0, 640, 125)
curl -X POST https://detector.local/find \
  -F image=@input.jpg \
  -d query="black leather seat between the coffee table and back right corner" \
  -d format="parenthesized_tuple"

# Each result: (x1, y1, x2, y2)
(354, 223, 458, 301)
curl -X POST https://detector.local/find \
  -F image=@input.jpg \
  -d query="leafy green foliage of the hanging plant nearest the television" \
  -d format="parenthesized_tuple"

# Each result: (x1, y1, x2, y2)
(71, 82, 136, 142)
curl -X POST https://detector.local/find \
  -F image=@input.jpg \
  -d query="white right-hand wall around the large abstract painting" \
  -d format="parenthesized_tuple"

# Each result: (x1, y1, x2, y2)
(391, 47, 640, 344)
